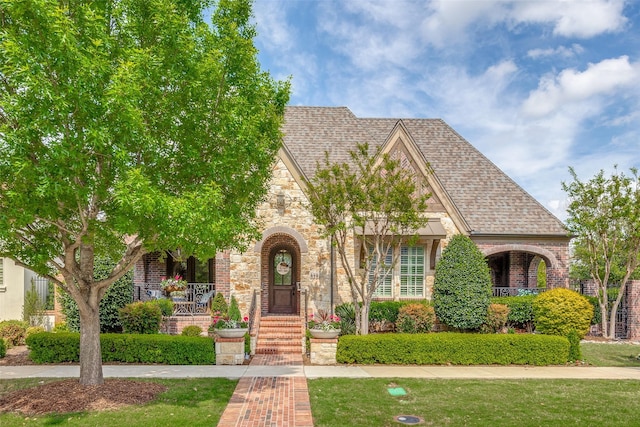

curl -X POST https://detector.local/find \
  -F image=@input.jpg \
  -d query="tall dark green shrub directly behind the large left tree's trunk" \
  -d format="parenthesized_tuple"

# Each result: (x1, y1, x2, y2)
(58, 258, 133, 333)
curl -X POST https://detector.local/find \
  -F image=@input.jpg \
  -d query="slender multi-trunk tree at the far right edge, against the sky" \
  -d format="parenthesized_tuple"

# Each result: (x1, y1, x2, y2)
(562, 168, 640, 338)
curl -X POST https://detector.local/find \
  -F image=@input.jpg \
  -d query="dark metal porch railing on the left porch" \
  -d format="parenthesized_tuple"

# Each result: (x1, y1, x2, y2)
(133, 283, 215, 316)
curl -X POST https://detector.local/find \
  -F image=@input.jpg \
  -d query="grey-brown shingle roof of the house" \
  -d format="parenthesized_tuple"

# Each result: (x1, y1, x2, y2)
(283, 107, 567, 236)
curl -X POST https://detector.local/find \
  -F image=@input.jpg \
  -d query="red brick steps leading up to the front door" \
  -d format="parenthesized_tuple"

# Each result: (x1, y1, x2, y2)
(256, 316, 304, 354)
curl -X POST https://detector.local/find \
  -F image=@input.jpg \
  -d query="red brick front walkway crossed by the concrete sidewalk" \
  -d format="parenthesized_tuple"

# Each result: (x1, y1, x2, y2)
(218, 354, 313, 427)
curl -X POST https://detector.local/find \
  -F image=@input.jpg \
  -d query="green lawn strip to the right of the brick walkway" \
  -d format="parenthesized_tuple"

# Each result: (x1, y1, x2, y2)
(308, 378, 640, 427)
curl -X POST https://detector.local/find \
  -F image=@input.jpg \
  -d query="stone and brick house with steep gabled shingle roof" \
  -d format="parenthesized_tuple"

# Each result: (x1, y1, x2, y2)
(134, 107, 569, 348)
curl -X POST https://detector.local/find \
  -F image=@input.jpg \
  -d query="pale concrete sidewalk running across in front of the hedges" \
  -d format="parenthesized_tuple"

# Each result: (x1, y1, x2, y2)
(0, 365, 640, 380)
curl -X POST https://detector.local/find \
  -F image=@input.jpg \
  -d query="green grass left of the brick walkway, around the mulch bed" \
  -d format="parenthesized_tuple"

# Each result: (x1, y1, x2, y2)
(0, 378, 237, 427)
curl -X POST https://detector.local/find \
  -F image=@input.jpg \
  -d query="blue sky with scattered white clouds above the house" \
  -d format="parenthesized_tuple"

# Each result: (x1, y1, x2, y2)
(254, 0, 640, 219)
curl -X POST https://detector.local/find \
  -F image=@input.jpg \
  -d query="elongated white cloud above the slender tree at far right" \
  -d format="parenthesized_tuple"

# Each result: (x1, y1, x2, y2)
(522, 56, 640, 117)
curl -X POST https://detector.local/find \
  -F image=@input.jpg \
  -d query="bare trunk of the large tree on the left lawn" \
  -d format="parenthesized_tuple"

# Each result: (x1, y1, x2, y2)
(79, 304, 104, 385)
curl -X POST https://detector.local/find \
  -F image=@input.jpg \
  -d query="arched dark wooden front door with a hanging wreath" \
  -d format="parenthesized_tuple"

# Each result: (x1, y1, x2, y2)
(269, 249, 298, 314)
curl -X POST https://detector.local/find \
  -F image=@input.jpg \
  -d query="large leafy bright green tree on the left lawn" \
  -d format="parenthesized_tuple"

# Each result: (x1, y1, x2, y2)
(0, 0, 289, 384)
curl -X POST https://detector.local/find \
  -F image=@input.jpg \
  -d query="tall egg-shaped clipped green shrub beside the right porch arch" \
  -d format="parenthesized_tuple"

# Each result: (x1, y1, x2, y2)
(433, 234, 491, 330)
